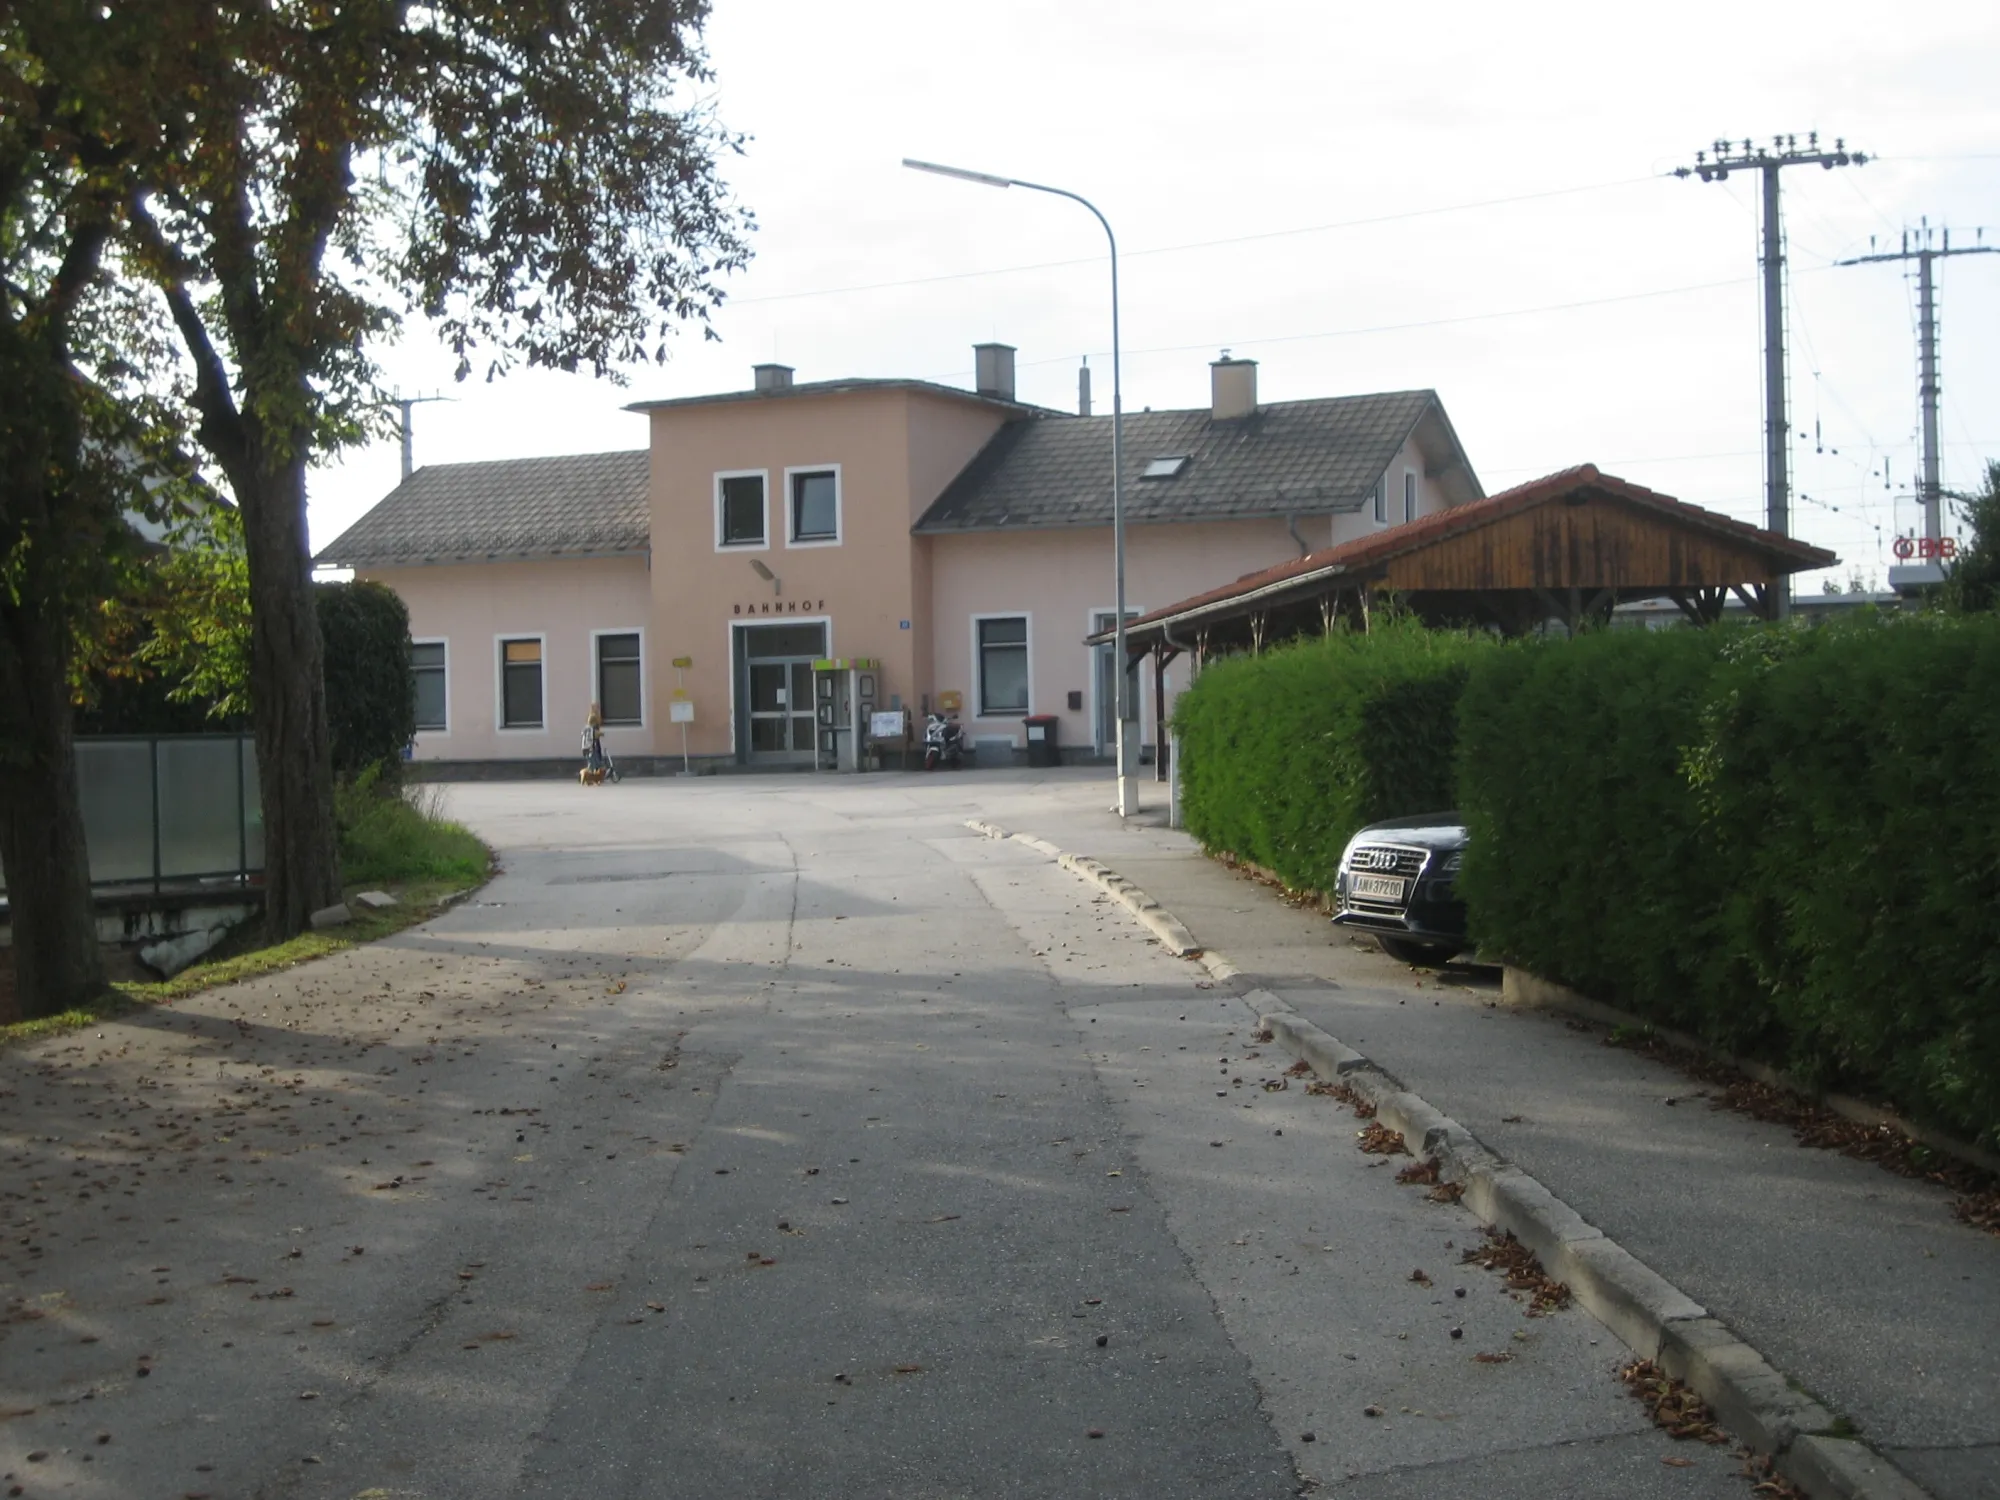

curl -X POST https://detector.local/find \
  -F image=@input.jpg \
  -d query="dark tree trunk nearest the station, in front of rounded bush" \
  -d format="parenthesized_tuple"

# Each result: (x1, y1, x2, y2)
(236, 456, 340, 942)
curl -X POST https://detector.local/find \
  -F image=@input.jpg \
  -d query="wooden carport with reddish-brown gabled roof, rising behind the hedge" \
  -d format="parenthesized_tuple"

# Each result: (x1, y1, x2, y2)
(1090, 464, 1838, 776)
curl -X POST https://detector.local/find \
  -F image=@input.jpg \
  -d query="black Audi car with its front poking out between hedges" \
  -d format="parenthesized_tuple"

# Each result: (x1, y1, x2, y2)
(1334, 812, 1472, 964)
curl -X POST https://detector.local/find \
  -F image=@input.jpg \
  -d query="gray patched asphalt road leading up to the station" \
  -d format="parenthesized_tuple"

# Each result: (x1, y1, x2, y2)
(0, 776, 1748, 1500)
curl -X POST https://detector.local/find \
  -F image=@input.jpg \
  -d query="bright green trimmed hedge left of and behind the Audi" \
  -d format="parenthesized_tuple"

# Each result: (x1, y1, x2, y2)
(1174, 622, 1496, 890)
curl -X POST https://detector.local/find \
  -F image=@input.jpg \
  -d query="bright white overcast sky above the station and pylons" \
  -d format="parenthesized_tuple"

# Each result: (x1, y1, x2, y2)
(310, 0, 2000, 590)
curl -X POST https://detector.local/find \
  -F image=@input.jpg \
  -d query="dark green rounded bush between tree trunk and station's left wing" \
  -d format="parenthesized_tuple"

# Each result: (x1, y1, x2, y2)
(314, 582, 416, 776)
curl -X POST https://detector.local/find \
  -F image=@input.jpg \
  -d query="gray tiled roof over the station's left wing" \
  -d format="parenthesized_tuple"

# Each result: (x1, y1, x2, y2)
(314, 448, 652, 568)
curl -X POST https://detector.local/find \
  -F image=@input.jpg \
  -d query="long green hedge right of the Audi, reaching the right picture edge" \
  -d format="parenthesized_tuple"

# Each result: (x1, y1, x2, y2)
(1460, 616, 2000, 1144)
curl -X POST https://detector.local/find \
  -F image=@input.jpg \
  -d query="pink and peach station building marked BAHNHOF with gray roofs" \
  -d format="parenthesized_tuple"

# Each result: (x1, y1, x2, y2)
(318, 354, 1480, 772)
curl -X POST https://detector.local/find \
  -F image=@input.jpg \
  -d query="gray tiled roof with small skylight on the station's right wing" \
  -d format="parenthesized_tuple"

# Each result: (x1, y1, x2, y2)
(916, 390, 1462, 532)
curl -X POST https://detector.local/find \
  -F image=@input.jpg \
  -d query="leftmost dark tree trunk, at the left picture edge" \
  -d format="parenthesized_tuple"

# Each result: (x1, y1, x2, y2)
(0, 588, 104, 1018)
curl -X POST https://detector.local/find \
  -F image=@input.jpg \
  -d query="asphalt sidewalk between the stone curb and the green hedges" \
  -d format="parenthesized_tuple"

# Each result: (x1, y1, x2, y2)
(964, 778, 2000, 1500)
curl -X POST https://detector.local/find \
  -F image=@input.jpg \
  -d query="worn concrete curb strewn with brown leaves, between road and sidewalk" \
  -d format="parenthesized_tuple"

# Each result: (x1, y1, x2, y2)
(966, 818, 1932, 1500)
